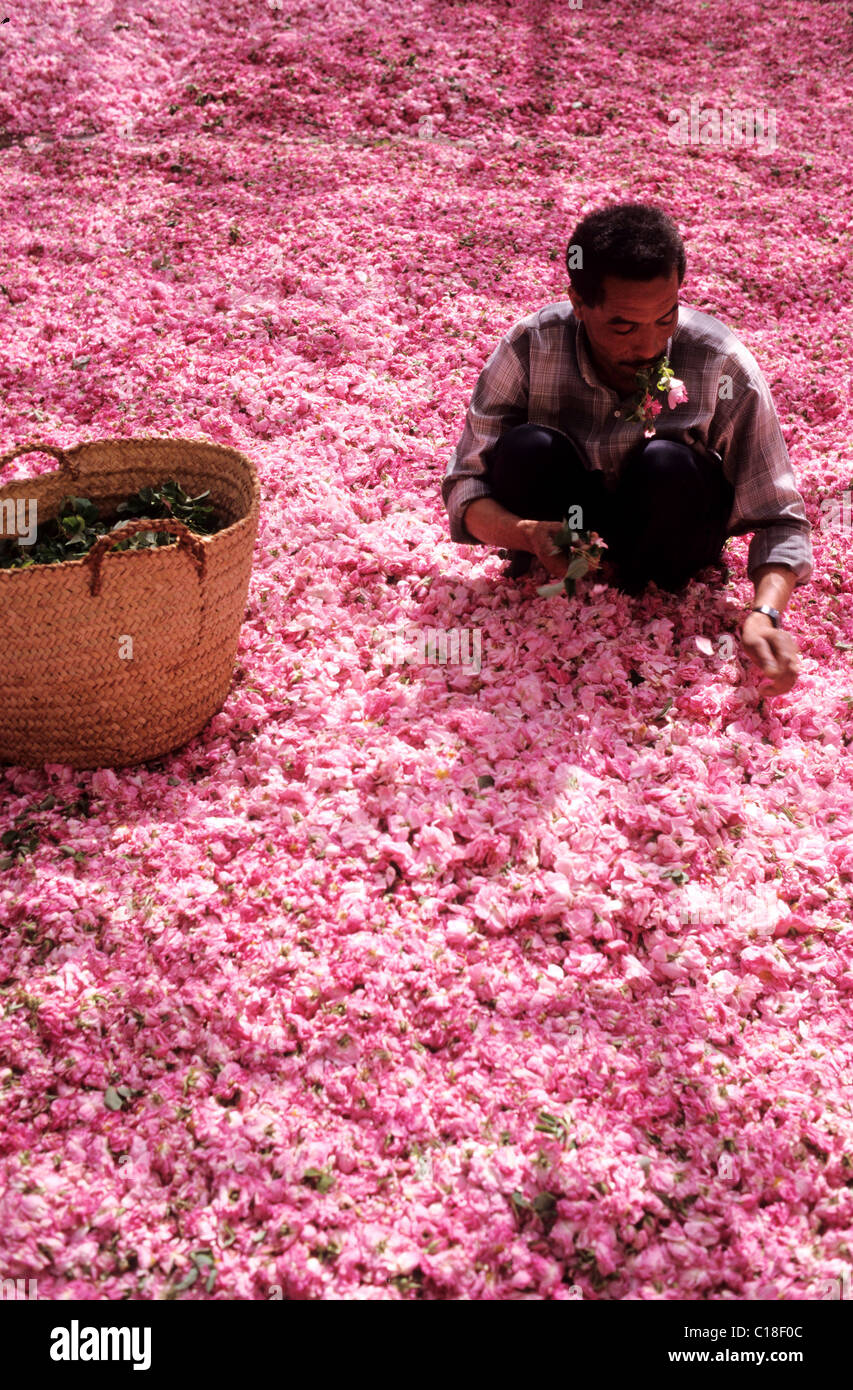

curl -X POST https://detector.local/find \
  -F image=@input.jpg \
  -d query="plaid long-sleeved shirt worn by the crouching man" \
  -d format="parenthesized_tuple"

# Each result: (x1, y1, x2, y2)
(442, 300, 813, 587)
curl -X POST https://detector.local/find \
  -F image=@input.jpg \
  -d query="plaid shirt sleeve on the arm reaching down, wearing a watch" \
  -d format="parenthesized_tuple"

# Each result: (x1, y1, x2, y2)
(710, 349, 814, 587)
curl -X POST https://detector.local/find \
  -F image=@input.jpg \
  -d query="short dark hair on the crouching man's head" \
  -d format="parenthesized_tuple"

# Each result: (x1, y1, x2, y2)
(565, 203, 686, 309)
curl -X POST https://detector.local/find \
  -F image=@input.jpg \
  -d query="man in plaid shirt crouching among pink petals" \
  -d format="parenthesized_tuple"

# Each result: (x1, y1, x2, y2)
(442, 203, 813, 695)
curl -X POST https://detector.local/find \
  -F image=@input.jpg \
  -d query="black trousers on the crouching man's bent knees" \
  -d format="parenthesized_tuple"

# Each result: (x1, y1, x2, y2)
(486, 423, 735, 591)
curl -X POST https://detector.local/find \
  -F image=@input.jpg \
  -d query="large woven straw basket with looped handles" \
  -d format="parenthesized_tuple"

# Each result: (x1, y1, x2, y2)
(0, 439, 260, 767)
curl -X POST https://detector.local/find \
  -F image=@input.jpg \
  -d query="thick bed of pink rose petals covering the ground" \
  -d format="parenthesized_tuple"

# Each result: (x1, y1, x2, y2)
(0, 0, 853, 1300)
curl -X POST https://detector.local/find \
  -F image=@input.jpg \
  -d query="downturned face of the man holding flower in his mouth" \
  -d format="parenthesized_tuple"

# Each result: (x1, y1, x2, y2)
(568, 270, 678, 396)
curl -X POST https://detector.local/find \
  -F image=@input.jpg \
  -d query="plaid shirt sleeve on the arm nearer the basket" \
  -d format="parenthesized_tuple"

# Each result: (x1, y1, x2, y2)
(442, 324, 529, 545)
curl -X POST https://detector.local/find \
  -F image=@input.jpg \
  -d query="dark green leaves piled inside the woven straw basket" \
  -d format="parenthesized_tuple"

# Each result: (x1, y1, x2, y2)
(0, 478, 222, 570)
